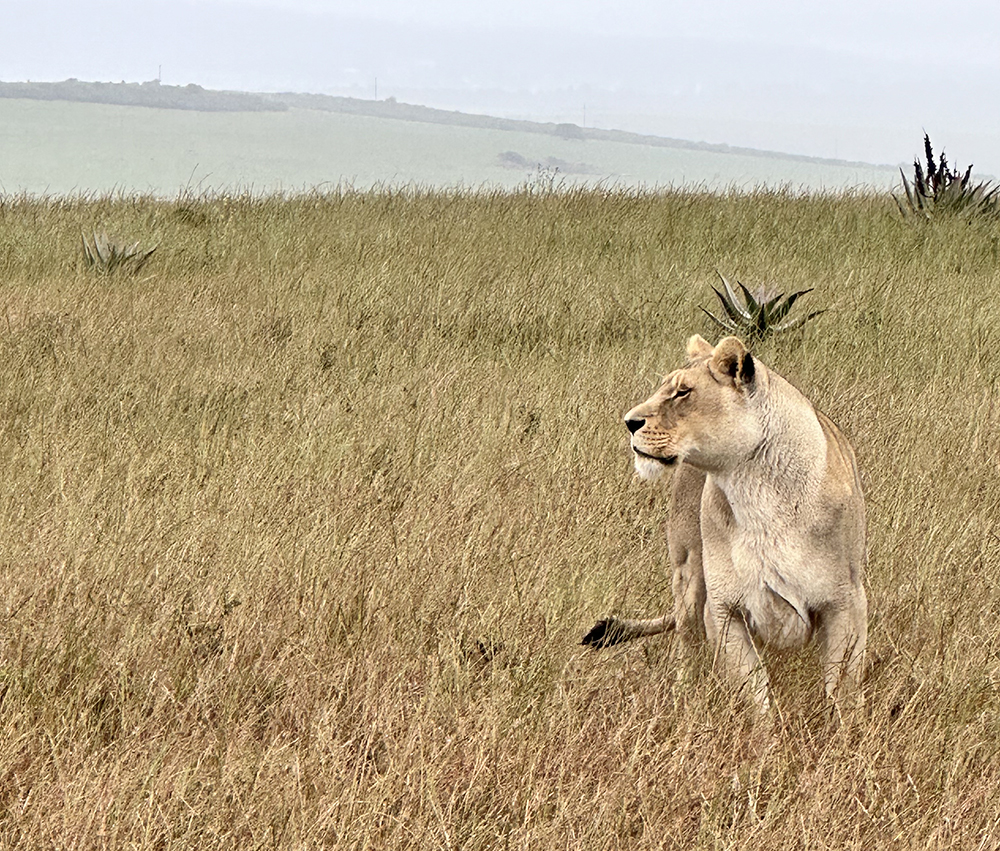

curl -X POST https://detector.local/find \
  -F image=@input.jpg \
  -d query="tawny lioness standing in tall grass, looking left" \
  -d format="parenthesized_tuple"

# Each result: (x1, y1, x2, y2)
(583, 335, 868, 712)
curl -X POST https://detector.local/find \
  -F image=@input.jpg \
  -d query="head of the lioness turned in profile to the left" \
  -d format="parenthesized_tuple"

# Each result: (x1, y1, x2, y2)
(625, 334, 763, 479)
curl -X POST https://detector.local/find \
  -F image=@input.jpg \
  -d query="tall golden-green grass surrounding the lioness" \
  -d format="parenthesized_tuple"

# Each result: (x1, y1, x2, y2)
(0, 190, 1000, 851)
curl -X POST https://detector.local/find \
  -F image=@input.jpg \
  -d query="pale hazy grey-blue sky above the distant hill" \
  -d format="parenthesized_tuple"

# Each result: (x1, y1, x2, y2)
(0, 0, 1000, 175)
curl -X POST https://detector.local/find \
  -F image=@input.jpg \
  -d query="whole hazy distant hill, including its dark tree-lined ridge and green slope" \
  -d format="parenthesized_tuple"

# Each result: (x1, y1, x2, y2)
(0, 79, 898, 195)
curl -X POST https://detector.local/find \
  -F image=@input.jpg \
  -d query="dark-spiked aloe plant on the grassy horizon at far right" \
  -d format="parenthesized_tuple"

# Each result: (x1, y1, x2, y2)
(893, 133, 1000, 219)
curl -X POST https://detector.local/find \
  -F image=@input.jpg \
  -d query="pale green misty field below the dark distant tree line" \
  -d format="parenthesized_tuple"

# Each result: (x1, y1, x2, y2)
(0, 98, 900, 198)
